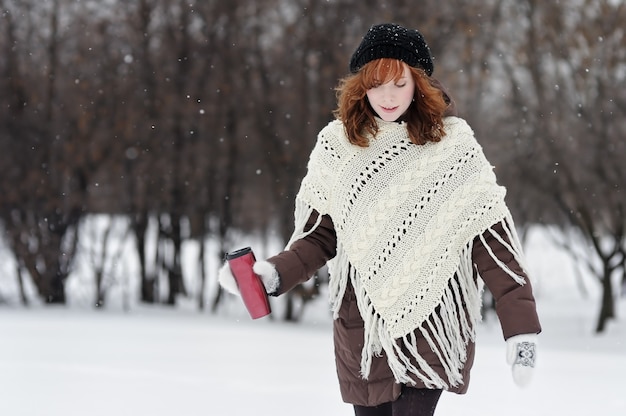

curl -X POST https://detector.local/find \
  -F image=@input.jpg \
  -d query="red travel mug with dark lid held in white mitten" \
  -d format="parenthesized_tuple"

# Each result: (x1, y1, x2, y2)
(226, 247, 271, 319)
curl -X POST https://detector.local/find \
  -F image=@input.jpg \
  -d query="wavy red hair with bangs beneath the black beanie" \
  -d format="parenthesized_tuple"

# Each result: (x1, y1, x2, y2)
(333, 58, 448, 147)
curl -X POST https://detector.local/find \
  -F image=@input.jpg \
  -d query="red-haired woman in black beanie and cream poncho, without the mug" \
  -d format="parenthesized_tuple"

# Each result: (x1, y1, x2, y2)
(220, 24, 541, 416)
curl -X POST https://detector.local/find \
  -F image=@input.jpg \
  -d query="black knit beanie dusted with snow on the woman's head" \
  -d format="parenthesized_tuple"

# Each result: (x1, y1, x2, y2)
(350, 23, 435, 76)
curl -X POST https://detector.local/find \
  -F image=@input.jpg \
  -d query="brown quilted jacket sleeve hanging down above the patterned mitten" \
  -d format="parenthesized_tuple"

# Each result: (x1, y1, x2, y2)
(472, 223, 541, 339)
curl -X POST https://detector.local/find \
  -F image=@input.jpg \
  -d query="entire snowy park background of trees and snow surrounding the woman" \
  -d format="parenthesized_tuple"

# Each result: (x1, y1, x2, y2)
(0, 0, 626, 416)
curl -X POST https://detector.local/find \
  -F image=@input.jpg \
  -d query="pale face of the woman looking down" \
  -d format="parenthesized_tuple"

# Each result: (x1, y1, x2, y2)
(366, 64, 415, 121)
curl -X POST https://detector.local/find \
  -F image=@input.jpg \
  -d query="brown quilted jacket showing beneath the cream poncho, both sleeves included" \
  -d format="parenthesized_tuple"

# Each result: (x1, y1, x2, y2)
(268, 214, 541, 406)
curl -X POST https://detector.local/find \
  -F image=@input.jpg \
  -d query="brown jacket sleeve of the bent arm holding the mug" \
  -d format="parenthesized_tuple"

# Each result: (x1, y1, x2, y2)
(267, 212, 337, 296)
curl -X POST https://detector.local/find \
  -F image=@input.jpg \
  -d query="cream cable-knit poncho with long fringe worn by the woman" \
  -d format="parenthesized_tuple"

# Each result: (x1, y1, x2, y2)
(287, 117, 524, 389)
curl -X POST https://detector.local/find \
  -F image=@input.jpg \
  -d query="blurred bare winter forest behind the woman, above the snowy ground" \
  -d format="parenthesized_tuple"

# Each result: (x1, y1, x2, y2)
(0, 0, 626, 332)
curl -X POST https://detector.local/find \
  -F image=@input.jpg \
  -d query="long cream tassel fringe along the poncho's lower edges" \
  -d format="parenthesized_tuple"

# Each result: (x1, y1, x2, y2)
(287, 118, 525, 389)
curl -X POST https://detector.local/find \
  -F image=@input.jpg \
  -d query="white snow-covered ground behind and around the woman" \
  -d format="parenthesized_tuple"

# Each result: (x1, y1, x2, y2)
(0, 226, 626, 416)
